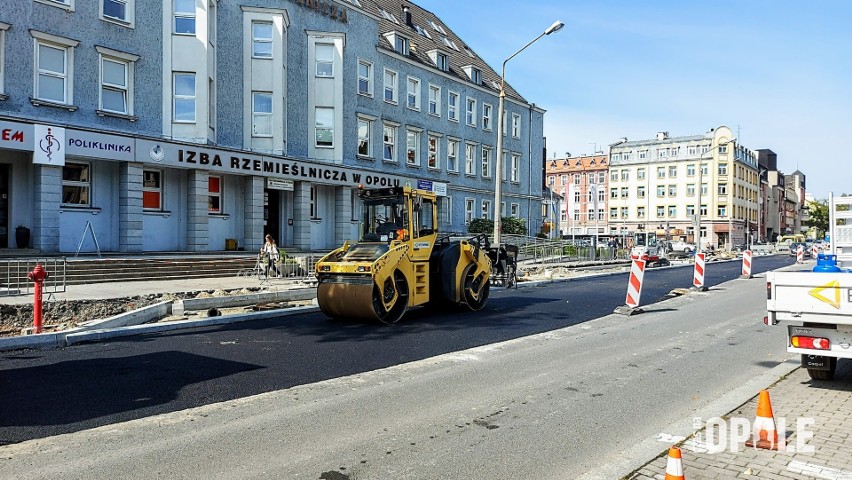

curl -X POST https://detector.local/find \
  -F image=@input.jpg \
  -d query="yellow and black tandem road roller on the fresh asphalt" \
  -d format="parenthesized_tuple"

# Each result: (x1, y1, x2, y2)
(316, 186, 502, 323)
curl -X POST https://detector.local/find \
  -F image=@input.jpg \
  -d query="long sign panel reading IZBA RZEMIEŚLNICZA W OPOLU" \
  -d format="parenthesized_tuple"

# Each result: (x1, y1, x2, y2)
(136, 140, 408, 187)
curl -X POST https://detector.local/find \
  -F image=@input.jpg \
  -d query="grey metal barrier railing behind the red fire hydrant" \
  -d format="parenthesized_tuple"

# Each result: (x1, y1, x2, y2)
(0, 257, 68, 297)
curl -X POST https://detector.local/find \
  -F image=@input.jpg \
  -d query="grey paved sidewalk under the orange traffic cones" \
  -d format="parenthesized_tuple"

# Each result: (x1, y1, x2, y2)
(627, 360, 852, 480)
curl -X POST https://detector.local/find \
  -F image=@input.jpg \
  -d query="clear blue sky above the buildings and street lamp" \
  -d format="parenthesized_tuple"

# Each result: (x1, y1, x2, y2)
(415, 0, 852, 198)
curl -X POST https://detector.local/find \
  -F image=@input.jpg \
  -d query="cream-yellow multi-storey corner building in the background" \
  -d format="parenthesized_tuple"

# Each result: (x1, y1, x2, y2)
(608, 126, 758, 248)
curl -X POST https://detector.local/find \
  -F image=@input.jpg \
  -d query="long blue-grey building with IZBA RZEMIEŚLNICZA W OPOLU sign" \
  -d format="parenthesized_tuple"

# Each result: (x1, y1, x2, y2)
(0, 0, 544, 253)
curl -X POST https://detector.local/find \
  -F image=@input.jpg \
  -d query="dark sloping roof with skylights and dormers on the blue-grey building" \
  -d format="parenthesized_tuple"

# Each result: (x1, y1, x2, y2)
(360, 0, 529, 103)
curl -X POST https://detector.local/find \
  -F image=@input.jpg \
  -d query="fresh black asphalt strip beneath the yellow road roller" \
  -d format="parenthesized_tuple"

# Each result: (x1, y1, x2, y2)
(0, 256, 792, 444)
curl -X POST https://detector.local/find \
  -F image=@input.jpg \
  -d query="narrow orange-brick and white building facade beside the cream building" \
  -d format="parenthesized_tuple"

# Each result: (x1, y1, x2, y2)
(547, 155, 610, 236)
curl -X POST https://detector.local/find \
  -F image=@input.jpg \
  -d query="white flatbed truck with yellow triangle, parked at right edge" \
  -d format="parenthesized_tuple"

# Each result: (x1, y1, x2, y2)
(764, 194, 852, 380)
